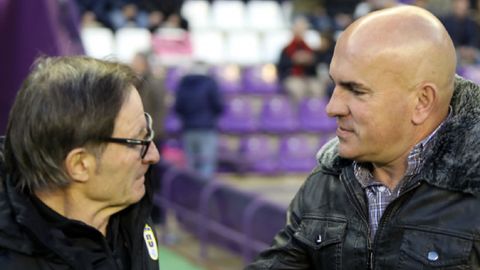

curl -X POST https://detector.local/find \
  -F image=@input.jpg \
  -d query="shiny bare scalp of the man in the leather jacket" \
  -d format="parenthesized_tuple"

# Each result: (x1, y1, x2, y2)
(336, 6, 456, 98)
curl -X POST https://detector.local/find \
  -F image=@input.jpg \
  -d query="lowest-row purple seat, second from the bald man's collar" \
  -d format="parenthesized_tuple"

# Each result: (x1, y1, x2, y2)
(240, 134, 278, 174)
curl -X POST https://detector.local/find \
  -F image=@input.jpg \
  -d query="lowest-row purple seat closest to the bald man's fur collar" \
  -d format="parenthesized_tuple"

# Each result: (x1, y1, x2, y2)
(278, 134, 321, 172)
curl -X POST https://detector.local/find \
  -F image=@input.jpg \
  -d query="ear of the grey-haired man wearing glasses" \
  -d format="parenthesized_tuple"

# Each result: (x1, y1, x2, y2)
(65, 148, 96, 182)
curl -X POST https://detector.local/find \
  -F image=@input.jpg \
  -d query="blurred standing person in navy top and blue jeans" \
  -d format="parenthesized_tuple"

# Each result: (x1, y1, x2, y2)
(174, 63, 224, 179)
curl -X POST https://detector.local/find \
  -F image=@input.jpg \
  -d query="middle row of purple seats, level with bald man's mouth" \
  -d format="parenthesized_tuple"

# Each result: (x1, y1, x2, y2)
(165, 94, 336, 134)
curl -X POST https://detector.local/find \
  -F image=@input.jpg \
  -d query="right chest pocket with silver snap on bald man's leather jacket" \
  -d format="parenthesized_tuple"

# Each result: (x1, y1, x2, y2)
(397, 229, 473, 270)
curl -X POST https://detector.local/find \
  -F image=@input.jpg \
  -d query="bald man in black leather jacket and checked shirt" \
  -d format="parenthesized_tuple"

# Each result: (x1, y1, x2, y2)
(246, 6, 480, 270)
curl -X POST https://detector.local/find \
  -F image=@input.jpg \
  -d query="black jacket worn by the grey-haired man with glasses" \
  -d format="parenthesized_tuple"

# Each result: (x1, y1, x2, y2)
(0, 138, 159, 270)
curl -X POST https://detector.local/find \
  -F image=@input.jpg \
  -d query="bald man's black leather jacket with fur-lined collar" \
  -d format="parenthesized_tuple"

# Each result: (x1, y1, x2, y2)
(246, 78, 480, 270)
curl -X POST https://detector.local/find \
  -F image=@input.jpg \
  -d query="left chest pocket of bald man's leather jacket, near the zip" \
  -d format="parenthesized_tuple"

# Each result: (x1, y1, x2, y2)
(293, 215, 347, 270)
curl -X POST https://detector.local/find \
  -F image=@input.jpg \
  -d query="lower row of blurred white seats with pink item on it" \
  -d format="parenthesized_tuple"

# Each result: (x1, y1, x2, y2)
(81, 27, 320, 66)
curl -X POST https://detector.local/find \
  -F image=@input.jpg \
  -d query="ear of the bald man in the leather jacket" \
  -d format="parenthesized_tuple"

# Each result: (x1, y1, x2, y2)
(412, 83, 438, 125)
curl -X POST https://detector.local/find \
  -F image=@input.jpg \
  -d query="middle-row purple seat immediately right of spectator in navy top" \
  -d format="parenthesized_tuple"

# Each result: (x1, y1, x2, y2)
(219, 95, 258, 133)
